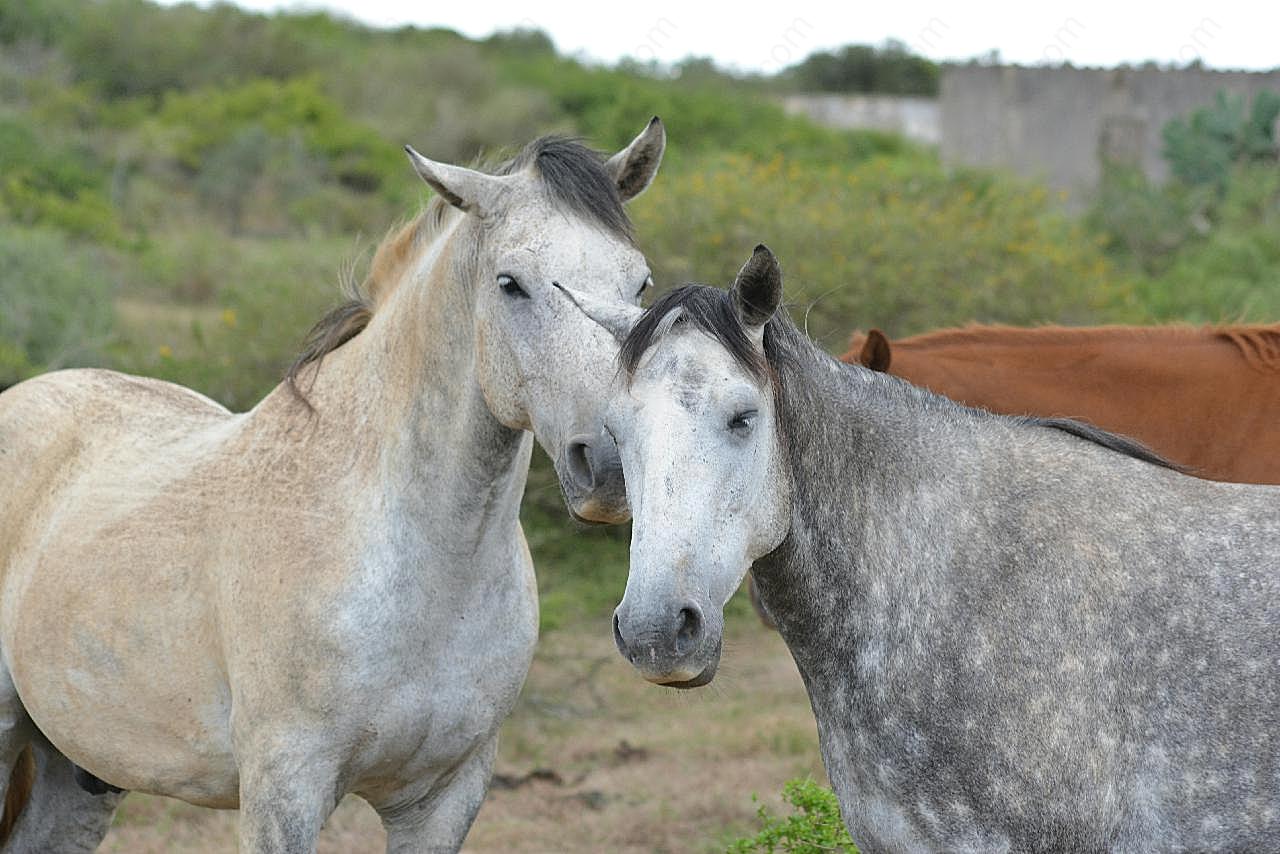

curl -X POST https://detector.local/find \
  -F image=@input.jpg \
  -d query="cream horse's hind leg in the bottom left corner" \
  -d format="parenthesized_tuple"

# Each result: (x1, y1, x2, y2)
(4, 735, 124, 854)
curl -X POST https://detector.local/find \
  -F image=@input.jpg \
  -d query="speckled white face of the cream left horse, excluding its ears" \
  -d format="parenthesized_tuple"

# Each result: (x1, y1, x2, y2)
(475, 206, 650, 522)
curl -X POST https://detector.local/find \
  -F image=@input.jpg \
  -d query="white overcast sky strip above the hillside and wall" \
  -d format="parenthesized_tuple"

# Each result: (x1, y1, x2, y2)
(154, 0, 1280, 72)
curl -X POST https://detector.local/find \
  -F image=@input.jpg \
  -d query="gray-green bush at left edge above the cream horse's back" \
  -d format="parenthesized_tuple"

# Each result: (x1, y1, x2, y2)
(0, 228, 115, 385)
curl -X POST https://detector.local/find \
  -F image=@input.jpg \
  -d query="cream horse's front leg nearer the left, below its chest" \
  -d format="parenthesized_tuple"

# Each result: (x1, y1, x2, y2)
(237, 739, 340, 854)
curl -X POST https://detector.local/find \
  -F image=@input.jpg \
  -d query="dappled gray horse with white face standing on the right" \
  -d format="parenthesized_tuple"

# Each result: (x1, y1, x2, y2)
(565, 247, 1280, 851)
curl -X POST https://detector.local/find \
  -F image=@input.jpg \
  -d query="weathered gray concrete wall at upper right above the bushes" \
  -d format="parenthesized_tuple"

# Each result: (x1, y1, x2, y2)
(940, 65, 1280, 192)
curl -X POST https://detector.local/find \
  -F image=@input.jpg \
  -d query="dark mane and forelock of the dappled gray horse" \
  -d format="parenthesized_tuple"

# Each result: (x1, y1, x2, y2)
(618, 284, 1188, 474)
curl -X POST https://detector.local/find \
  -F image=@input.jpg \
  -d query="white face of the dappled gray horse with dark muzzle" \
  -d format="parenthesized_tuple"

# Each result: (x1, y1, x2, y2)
(605, 250, 791, 688)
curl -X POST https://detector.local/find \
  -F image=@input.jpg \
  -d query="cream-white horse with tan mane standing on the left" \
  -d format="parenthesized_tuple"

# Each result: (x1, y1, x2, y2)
(0, 119, 666, 851)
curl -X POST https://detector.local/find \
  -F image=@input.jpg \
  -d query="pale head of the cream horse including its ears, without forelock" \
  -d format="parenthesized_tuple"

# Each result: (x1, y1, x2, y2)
(404, 119, 666, 522)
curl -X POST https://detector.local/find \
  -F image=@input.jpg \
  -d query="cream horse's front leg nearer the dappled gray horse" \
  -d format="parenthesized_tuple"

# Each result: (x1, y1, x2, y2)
(375, 736, 498, 854)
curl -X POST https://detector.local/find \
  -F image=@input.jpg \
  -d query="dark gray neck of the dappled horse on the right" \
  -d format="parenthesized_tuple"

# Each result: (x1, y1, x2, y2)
(756, 356, 972, 665)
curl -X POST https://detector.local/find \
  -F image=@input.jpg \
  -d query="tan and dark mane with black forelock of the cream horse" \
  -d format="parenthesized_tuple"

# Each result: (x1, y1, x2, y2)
(284, 136, 635, 408)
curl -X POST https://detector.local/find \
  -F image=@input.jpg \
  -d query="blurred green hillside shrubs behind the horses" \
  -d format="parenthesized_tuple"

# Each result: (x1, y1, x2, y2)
(0, 0, 1280, 627)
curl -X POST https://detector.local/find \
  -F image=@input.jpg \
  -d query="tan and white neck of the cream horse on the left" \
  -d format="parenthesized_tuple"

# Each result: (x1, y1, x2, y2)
(255, 220, 531, 553)
